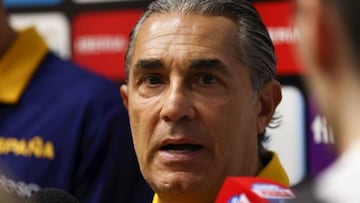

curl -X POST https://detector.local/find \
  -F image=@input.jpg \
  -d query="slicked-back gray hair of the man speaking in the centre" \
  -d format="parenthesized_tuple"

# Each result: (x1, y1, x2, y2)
(125, 0, 276, 91)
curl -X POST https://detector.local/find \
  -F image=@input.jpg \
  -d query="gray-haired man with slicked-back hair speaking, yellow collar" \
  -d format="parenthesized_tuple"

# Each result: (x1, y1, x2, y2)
(121, 0, 288, 203)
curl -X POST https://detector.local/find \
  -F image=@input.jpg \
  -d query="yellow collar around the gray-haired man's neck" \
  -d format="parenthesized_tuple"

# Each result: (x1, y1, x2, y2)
(152, 152, 289, 203)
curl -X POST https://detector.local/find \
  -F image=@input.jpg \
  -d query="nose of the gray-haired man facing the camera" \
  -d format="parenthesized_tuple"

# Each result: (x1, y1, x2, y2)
(160, 81, 195, 122)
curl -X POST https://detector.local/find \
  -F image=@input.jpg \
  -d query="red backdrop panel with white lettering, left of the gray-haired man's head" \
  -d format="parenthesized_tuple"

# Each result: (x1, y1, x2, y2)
(72, 9, 142, 82)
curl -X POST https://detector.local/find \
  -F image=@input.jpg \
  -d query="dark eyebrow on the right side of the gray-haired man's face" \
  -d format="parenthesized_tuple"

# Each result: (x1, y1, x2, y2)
(189, 59, 230, 75)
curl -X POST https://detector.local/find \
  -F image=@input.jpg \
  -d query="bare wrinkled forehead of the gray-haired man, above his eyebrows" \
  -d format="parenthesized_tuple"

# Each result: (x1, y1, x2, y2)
(133, 13, 237, 64)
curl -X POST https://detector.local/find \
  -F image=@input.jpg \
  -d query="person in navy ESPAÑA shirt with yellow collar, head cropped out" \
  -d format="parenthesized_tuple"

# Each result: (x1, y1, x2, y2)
(0, 2, 152, 203)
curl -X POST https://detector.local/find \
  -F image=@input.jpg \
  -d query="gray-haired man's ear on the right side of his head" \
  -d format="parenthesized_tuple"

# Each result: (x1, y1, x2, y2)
(257, 80, 282, 134)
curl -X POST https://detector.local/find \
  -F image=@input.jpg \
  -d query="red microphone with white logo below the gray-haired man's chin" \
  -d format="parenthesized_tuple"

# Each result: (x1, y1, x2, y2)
(215, 177, 295, 203)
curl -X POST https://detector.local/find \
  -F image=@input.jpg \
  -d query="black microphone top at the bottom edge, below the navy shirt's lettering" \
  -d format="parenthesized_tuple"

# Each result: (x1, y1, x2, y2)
(25, 188, 80, 203)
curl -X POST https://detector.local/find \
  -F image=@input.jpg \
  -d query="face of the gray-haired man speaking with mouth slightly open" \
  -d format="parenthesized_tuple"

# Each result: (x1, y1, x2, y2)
(121, 14, 259, 197)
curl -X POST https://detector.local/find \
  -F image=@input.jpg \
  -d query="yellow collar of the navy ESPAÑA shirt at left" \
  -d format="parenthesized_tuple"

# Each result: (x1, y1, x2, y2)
(0, 28, 48, 104)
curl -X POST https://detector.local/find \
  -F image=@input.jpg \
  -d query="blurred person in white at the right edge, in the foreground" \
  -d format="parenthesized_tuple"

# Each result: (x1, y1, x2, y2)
(296, 0, 360, 203)
